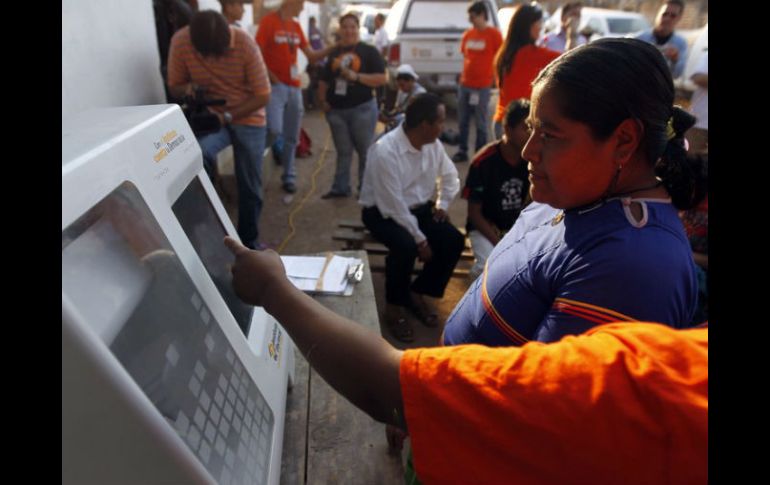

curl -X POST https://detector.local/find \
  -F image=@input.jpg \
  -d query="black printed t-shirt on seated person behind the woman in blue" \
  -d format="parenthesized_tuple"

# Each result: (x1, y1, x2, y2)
(463, 141, 529, 232)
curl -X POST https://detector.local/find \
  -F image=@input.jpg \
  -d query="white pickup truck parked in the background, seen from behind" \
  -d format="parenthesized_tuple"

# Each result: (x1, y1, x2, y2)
(385, 0, 499, 92)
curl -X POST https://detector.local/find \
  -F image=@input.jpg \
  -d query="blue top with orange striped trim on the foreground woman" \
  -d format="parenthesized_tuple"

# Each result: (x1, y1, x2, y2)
(444, 199, 698, 346)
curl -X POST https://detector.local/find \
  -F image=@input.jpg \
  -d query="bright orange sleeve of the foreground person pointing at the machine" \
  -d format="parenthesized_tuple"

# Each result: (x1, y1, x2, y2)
(400, 323, 708, 485)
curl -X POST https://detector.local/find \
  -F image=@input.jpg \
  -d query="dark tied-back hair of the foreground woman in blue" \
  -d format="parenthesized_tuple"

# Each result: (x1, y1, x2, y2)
(532, 38, 699, 209)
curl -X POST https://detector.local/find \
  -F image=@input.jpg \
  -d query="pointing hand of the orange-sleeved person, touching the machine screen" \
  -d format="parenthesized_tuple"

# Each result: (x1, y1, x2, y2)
(225, 236, 291, 306)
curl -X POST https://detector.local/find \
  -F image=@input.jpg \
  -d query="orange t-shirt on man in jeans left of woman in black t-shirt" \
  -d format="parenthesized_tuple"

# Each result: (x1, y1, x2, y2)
(257, 12, 308, 86)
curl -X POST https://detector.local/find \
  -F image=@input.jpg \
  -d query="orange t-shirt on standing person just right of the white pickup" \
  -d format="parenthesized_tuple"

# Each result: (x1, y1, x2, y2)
(460, 27, 503, 89)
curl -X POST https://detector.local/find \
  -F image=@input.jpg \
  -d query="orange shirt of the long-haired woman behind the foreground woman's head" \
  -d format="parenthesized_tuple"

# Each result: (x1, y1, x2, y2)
(495, 45, 561, 121)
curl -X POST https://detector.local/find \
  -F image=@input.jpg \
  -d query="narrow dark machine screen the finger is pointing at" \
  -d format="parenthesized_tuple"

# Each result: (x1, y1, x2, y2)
(171, 177, 254, 335)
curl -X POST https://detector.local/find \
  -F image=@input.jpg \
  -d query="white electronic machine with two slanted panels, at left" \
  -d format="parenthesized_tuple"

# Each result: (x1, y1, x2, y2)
(62, 105, 294, 484)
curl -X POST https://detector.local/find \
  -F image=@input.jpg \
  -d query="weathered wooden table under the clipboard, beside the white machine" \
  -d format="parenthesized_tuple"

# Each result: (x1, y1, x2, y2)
(280, 251, 404, 485)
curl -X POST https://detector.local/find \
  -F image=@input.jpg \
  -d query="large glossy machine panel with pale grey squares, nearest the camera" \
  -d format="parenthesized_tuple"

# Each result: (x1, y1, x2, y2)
(62, 183, 275, 484)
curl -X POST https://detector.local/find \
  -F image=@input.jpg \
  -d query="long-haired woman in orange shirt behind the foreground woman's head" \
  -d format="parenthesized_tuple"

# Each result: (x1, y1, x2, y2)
(494, 5, 560, 138)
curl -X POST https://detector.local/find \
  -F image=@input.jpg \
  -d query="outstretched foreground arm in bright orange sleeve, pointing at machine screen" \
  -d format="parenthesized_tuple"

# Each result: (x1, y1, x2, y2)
(225, 238, 708, 485)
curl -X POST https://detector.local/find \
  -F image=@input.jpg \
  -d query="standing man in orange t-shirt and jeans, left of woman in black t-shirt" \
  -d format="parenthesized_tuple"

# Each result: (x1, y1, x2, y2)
(257, 0, 335, 194)
